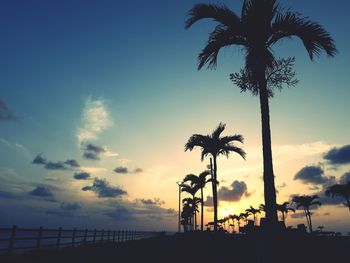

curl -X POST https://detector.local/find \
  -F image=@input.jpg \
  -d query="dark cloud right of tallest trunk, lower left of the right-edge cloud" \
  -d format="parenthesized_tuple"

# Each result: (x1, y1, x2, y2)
(294, 166, 329, 184)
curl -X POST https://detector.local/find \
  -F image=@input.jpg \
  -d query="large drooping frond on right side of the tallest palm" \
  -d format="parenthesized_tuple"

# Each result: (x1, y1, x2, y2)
(267, 12, 337, 60)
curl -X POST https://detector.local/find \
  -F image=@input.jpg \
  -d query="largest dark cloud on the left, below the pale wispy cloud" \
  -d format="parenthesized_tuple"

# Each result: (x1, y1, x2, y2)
(82, 178, 127, 198)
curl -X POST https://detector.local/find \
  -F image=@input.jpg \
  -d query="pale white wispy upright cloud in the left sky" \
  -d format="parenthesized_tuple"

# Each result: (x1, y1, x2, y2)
(76, 98, 113, 144)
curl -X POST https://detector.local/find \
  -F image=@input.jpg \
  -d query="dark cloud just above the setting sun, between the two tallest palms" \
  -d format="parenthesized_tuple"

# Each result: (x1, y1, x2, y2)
(218, 181, 250, 202)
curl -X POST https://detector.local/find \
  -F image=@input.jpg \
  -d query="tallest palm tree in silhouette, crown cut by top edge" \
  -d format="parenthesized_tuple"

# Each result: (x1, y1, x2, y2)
(185, 0, 337, 229)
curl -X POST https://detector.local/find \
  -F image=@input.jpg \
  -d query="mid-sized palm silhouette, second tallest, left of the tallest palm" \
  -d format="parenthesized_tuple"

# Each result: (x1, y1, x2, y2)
(185, 123, 246, 231)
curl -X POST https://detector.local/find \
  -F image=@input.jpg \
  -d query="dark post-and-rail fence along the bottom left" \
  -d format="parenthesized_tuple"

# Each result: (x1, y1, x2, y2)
(0, 226, 164, 255)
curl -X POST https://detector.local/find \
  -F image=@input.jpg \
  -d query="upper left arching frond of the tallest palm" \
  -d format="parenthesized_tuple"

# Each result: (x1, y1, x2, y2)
(185, 4, 240, 29)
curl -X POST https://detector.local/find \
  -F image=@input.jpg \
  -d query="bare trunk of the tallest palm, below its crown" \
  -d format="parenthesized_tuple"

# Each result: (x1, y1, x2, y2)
(259, 75, 278, 227)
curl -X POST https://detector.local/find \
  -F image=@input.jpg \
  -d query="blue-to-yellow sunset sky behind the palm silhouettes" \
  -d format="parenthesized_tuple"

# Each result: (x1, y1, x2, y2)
(0, 0, 350, 233)
